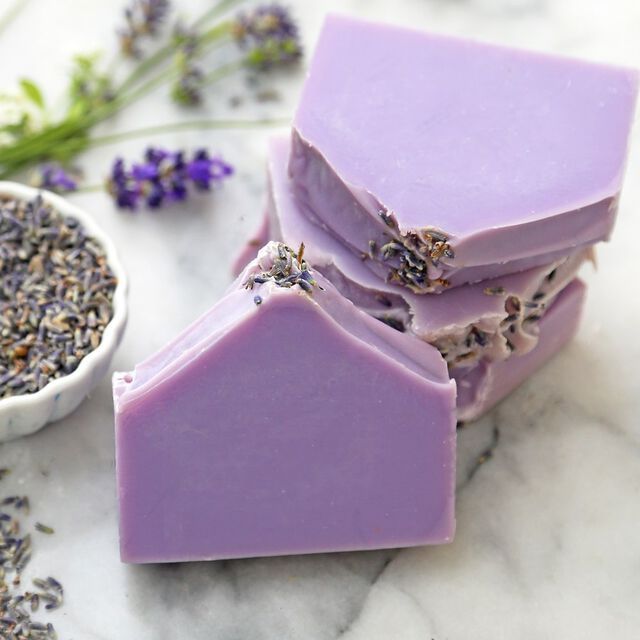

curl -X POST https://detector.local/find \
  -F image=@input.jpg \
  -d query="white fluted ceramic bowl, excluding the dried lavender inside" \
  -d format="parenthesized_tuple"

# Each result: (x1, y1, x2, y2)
(0, 181, 127, 442)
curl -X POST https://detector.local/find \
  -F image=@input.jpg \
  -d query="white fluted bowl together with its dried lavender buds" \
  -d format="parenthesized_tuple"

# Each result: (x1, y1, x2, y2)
(0, 182, 127, 442)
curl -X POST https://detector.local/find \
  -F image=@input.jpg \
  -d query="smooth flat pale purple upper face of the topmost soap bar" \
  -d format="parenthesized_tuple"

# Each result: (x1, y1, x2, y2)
(294, 15, 637, 239)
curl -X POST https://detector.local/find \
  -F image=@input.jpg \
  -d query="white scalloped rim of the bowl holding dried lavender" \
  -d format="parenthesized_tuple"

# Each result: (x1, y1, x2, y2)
(0, 180, 129, 415)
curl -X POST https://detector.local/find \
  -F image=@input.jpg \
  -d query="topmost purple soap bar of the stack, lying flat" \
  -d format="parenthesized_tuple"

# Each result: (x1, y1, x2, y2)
(289, 16, 638, 293)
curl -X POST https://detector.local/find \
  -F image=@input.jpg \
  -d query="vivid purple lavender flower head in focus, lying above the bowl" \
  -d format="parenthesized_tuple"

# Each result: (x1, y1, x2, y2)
(107, 147, 233, 210)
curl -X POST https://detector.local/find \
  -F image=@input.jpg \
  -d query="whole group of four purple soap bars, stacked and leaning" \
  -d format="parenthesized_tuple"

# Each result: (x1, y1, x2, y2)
(114, 16, 637, 562)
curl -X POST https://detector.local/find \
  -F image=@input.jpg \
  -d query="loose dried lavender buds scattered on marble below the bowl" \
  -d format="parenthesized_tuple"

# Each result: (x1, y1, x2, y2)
(0, 469, 64, 640)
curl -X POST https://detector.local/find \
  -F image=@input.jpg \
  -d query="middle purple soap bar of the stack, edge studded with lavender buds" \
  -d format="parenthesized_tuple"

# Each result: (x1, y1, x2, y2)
(234, 137, 591, 420)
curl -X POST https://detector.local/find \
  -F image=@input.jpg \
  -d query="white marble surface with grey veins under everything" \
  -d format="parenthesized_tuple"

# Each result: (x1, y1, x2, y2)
(0, 0, 640, 640)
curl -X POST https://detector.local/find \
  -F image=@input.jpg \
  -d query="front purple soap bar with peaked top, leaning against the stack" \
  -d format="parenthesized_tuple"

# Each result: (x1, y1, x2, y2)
(114, 243, 455, 563)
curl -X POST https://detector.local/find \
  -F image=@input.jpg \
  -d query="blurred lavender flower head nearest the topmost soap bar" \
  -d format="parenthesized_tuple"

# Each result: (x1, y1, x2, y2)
(231, 4, 302, 71)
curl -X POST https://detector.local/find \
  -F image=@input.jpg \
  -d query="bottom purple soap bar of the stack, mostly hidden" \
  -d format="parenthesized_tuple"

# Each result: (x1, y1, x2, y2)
(452, 278, 586, 420)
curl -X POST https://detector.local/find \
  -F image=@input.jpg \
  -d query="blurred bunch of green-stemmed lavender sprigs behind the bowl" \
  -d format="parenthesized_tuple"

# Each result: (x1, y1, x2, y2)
(0, 0, 302, 179)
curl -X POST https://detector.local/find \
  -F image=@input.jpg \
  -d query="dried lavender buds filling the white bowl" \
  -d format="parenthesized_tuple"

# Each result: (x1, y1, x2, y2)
(0, 198, 117, 399)
